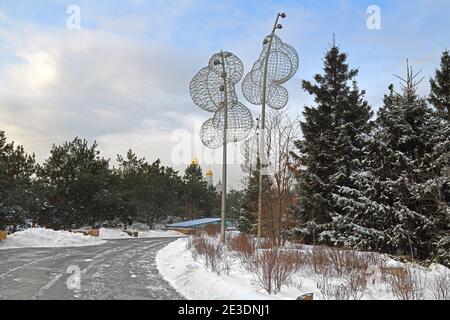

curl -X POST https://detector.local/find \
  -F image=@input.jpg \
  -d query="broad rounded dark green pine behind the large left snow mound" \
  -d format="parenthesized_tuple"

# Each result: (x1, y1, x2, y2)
(38, 138, 122, 229)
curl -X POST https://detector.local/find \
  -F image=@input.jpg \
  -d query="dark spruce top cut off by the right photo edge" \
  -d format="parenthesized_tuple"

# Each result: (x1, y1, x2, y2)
(430, 50, 450, 122)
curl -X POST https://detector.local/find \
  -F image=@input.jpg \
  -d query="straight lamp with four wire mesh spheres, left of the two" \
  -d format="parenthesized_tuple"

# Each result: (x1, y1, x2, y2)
(190, 51, 253, 242)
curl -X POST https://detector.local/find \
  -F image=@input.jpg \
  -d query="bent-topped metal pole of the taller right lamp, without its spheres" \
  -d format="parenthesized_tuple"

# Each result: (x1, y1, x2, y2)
(258, 13, 281, 242)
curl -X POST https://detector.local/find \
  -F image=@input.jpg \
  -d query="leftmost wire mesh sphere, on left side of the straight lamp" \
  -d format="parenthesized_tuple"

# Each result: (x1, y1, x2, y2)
(190, 67, 237, 112)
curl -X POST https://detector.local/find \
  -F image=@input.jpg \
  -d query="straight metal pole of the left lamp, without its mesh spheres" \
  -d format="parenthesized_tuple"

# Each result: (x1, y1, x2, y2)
(220, 52, 228, 243)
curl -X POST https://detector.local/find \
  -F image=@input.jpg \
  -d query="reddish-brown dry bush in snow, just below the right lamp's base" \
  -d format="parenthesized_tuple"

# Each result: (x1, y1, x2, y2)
(251, 249, 299, 294)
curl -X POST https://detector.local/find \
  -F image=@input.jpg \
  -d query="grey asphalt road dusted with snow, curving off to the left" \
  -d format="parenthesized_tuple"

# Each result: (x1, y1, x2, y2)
(0, 238, 183, 300)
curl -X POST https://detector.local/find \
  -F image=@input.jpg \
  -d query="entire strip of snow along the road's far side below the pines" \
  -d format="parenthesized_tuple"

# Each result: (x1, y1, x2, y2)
(0, 228, 184, 250)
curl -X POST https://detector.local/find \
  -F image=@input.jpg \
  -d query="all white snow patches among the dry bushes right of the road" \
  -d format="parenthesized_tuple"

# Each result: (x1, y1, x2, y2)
(156, 239, 450, 300)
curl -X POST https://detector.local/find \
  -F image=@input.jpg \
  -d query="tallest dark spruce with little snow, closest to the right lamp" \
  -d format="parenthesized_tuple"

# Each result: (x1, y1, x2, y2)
(295, 44, 372, 242)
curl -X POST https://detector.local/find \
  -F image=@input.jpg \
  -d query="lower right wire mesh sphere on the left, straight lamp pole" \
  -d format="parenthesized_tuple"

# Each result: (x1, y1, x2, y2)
(213, 102, 254, 142)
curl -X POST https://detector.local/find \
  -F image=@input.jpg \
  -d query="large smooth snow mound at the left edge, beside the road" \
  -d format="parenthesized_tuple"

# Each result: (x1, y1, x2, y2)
(0, 228, 104, 249)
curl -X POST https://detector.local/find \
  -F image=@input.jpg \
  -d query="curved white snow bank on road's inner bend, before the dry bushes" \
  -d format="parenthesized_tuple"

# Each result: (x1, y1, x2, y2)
(156, 239, 318, 300)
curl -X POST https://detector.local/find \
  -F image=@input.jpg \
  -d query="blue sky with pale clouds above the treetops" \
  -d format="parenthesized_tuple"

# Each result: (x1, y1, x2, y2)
(0, 0, 450, 187)
